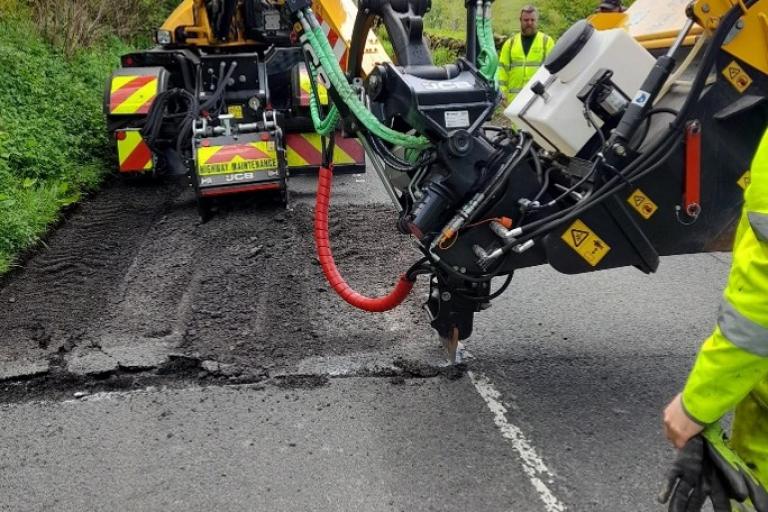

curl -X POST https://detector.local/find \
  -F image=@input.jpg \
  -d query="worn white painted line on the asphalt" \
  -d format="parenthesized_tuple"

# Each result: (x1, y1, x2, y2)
(467, 372, 566, 512)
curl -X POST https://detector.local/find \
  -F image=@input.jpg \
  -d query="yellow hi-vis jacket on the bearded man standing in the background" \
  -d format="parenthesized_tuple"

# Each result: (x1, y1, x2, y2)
(497, 32, 555, 101)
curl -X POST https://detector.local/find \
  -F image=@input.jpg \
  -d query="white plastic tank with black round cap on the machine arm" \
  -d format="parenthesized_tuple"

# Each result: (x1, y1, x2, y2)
(504, 21, 655, 156)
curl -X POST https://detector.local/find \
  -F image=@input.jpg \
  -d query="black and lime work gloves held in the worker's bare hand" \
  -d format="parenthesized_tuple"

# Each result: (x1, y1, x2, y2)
(659, 425, 768, 512)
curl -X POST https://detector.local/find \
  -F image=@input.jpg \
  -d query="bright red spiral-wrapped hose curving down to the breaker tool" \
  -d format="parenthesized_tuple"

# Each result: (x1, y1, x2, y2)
(315, 167, 414, 313)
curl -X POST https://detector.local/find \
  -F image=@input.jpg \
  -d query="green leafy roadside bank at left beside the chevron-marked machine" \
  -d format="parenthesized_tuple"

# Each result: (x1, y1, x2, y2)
(0, 0, 175, 274)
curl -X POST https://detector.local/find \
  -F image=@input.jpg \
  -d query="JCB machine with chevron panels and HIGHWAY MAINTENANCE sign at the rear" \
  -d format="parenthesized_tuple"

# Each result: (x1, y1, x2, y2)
(104, 0, 386, 218)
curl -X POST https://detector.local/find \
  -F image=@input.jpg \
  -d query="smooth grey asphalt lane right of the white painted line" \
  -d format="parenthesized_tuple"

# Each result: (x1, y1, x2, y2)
(470, 253, 730, 512)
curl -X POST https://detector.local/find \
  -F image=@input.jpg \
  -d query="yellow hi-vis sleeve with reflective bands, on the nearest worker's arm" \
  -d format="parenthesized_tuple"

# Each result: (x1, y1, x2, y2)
(683, 131, 768, 424)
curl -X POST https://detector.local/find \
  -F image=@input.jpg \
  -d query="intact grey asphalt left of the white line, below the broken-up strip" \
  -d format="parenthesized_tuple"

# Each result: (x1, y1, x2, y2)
(0, 378, 536, 511)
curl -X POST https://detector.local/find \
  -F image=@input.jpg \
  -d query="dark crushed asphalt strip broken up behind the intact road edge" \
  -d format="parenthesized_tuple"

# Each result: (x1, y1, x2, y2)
(0, 180, 456, 399)
